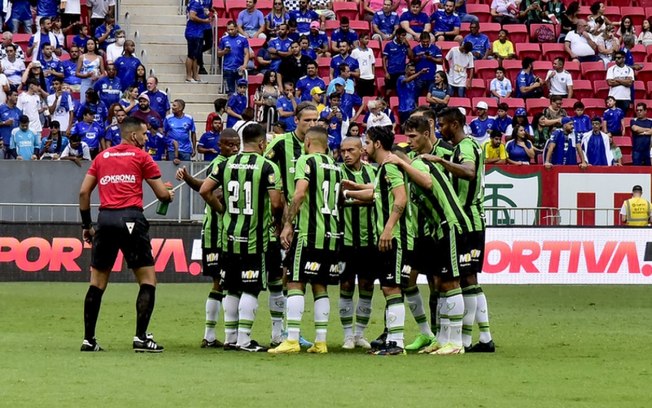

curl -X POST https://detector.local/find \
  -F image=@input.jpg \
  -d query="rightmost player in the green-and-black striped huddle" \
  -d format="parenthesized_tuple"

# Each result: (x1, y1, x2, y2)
(428, 108, 495, 352)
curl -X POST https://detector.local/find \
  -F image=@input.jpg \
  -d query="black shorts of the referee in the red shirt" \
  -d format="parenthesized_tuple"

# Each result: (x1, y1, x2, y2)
(91, 208, 154, 271)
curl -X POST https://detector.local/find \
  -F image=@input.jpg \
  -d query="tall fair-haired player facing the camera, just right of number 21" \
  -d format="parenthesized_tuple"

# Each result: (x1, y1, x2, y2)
(265, 102, 319, 346)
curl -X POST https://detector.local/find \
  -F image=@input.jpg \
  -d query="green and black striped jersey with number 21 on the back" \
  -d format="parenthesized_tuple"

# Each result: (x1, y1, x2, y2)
(210, 153, 281, 255)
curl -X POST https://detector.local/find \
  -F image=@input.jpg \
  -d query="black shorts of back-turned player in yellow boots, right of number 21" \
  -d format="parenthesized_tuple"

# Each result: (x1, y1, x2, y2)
(287, 243, 342, 285)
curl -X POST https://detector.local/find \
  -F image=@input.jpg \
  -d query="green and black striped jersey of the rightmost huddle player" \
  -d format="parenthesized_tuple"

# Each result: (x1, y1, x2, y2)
(452, 137, 485, 231)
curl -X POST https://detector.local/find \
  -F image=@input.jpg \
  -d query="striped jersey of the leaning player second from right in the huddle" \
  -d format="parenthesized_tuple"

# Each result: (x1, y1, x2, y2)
(410, 159, 471, 239)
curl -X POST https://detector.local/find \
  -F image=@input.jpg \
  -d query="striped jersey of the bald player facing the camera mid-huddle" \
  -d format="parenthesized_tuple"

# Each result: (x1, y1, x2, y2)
(341, 163, 376, 248)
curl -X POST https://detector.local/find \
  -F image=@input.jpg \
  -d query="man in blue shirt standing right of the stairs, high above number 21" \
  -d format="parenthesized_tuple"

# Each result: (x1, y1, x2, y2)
(217, 20, 251, 94)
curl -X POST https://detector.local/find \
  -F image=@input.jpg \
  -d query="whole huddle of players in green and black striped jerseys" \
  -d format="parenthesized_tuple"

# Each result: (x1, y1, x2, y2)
(177, 103, 494, 355)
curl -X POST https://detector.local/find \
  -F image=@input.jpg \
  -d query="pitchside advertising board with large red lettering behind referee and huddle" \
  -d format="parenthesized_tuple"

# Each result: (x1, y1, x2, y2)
(0, 223, 652, 284)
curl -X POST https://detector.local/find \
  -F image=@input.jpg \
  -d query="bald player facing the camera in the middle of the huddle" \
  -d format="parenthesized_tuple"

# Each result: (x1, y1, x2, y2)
(339, 137, 377, 350)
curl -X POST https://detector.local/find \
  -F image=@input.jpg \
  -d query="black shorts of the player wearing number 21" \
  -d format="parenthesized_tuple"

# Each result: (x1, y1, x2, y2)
(222, 252, 267, 295)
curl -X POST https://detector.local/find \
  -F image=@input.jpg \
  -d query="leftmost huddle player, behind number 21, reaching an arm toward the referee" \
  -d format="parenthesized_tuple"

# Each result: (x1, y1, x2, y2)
(176, 129, 240, 348)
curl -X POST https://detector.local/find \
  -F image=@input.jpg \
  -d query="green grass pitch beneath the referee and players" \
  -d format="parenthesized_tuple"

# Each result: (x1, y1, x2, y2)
(0, 283, 652, 408)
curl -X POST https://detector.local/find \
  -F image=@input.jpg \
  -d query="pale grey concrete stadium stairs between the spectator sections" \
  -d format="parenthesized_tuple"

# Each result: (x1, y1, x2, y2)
(118, 0, 222, 129)
